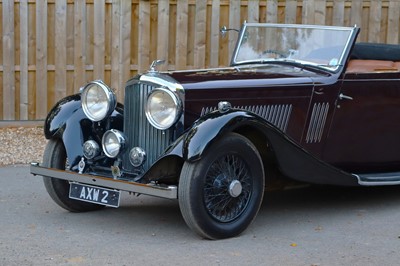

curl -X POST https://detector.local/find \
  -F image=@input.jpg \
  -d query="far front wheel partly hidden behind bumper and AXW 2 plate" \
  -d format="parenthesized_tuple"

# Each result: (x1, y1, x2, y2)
(43, 139, 104, 212)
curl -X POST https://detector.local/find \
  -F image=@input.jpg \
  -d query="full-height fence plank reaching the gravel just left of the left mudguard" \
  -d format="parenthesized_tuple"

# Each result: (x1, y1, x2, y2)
(35, 0, 48, 119)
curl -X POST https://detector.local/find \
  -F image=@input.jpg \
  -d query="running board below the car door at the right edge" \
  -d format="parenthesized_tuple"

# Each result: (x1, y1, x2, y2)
(353, 172, 400, 186)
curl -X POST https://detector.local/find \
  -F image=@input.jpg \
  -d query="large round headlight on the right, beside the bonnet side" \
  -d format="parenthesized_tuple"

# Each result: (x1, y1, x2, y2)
(146, 88, 181, 130)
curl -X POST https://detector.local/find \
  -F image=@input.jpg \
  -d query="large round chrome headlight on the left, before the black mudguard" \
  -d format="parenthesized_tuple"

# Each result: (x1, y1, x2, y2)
(81, 80, 117, 122)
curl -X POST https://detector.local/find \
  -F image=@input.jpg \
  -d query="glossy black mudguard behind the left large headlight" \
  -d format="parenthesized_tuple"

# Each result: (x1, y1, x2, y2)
(44, 94, 123, 167)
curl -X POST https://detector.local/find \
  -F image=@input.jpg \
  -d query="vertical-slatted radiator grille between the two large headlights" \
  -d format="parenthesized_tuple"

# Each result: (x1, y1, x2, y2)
(122, 83, 171, 172)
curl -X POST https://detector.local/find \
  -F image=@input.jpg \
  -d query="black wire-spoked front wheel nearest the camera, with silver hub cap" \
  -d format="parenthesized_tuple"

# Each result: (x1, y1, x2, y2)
(178, 133, 264, 239)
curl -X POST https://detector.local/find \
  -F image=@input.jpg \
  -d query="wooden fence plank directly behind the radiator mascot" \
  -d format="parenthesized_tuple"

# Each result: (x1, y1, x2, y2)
(157, 0, 169, 70)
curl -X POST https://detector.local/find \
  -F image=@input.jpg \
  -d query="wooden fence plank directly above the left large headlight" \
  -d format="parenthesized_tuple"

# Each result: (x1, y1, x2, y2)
(93, 0, 106, 80)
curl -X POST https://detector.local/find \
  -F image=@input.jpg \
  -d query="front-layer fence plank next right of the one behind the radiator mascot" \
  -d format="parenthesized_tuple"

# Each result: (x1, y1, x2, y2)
(175, 0, 189, 69)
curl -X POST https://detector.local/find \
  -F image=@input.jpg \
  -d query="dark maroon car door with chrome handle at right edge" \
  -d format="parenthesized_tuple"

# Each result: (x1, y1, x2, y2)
(323, 72, 400, 173)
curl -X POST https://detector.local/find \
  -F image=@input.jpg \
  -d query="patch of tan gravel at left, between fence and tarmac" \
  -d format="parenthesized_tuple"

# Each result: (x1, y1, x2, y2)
(0, 127, 47, 166)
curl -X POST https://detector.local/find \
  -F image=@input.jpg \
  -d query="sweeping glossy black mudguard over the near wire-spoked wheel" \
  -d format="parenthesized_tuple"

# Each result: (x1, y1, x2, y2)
(159, 110, 358, 186)
